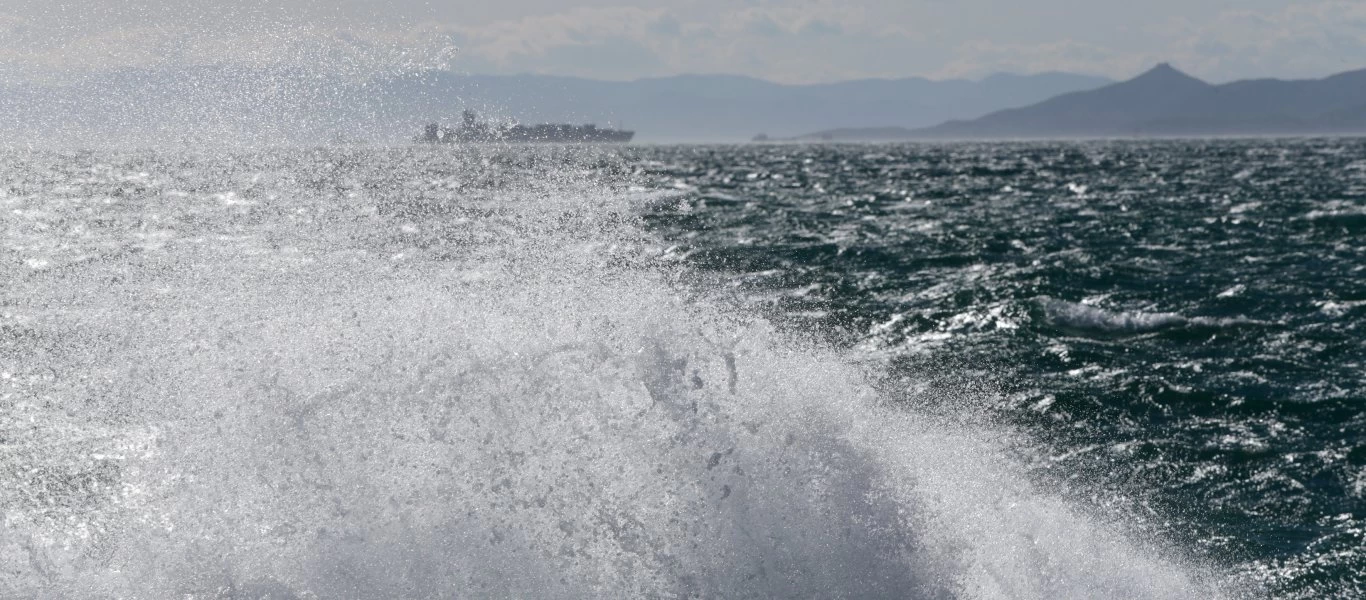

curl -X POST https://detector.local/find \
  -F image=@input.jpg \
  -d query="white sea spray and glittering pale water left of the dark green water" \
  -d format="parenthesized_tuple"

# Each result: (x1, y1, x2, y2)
(0, 148, 1228, 599)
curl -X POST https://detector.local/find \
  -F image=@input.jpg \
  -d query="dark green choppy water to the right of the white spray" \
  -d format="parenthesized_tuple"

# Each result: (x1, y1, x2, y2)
(634, 139, 1366, 597)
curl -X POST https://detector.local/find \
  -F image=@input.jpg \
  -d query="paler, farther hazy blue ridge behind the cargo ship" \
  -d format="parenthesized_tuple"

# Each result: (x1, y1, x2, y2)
(0, 66, 1109, 145)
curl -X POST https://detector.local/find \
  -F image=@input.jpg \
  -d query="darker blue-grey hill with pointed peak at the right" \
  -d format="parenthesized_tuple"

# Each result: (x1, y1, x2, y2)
(906, 64, 1366, 138)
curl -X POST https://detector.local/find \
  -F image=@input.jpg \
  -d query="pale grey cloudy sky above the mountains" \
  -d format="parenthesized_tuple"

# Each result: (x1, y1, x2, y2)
(0, 0, 1366, 83)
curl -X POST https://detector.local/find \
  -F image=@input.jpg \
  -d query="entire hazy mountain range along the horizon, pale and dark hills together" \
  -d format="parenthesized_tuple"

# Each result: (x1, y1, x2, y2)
(13, 64, 1366, 146)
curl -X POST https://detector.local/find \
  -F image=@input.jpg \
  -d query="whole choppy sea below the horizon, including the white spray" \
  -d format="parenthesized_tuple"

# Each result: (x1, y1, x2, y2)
(0, 138, 1366, 599)
